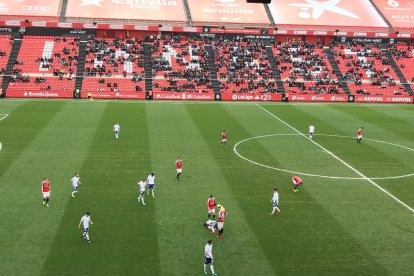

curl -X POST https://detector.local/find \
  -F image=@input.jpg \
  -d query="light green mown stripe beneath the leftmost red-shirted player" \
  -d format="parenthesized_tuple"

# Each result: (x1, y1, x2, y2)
(0, 103, 107, 275)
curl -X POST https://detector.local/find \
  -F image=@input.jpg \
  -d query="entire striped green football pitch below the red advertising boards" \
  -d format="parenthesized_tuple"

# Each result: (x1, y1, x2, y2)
(0, 100, 414, 276)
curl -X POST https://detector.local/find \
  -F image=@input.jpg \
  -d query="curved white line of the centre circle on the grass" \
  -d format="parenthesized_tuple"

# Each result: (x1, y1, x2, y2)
(233, 133, 414, 180)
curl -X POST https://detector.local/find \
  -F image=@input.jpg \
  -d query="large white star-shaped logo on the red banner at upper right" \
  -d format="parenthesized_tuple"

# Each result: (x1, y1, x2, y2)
(289, 0, 360, 19)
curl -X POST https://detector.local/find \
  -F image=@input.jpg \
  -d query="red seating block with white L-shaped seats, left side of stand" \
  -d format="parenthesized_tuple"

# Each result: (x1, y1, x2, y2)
(9, 36, 79, 91)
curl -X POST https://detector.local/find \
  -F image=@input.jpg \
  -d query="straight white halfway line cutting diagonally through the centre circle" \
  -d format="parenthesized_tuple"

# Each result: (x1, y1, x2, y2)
(257, 104, 414, 213)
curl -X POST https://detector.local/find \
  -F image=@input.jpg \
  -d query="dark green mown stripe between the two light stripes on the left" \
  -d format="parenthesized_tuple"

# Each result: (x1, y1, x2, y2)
(43, 103, 159, 275)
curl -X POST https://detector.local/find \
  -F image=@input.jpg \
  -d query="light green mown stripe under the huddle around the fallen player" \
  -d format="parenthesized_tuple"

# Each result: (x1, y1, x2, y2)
(147, 105, 273, 275)
